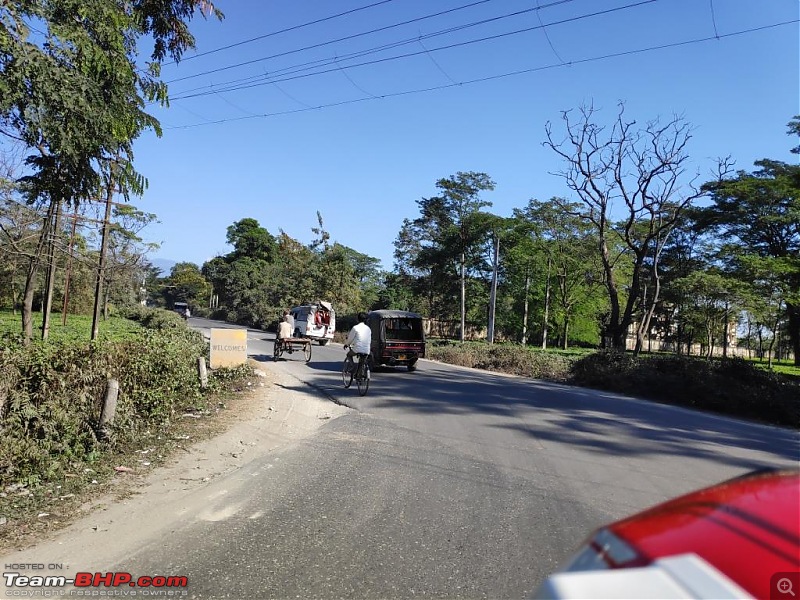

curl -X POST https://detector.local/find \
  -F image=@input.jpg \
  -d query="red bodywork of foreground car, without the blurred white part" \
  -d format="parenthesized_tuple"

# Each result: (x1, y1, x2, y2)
(539, 470, 800, 598)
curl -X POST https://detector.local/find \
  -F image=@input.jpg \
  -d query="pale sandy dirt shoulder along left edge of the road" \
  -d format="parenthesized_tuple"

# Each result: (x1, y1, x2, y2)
(0, 363, 351, 587)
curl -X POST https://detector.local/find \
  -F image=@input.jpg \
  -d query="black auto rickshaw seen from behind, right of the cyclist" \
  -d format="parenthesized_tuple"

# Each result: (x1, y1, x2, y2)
(367, 310, 425, 371)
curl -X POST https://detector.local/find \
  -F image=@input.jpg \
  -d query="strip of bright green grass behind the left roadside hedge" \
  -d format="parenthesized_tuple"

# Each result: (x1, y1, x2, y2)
(0, 309, 142, 341)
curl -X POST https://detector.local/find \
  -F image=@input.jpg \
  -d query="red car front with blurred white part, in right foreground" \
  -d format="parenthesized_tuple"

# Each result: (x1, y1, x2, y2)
(532, 469, 800, 598)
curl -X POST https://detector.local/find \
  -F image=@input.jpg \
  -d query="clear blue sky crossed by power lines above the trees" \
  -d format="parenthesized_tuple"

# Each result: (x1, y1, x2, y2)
(128, 0, 800, 270)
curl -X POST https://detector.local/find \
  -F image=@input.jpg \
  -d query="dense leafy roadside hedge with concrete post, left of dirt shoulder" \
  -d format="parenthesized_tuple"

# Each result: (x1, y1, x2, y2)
(0, 309, 238, 491)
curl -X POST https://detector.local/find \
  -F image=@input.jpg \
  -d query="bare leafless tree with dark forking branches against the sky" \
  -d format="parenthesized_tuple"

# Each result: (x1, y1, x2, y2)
(544, 102, 722, 352)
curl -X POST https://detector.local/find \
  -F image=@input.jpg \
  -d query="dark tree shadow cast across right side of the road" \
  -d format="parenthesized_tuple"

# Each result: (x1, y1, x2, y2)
(304, 363, 800, 469)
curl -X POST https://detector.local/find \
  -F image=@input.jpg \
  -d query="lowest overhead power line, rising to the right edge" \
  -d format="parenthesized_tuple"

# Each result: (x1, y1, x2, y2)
(164, 19, 800, 129)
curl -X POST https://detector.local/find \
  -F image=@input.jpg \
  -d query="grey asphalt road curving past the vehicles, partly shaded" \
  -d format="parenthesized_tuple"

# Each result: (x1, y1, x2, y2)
(109, 319, 800, 599)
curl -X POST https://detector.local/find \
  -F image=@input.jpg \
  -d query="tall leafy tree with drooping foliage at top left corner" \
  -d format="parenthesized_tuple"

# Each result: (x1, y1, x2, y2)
(0, 0, 221, 339)
